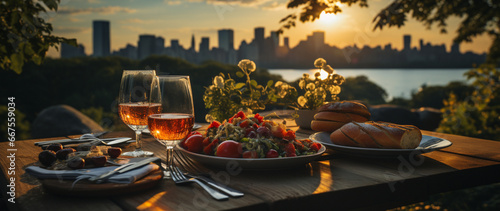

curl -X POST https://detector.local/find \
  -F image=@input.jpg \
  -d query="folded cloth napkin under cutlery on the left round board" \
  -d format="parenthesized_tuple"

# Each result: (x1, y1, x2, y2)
(25, 164, 160, 184)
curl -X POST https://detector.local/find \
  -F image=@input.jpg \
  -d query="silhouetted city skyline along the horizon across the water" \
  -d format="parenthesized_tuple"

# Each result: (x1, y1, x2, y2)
(61, 20, 486, 68)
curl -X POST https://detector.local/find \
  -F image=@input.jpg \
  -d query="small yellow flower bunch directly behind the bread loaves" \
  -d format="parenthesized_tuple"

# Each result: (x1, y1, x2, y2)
(296, 58, 345, 110)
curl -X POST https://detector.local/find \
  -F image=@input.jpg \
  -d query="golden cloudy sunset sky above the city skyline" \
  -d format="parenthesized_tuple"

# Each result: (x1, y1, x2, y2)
(47, 0, 491, 57)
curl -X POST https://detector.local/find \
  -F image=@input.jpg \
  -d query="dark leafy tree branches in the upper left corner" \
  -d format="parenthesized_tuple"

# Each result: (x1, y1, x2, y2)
(0, 0, 76, 74)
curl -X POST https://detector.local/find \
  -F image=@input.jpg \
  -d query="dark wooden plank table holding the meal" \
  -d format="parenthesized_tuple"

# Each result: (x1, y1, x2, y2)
(0, 123, 500, 211)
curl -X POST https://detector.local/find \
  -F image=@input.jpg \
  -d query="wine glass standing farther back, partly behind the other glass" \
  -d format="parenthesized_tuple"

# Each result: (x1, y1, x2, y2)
(118, 70, 161, 157)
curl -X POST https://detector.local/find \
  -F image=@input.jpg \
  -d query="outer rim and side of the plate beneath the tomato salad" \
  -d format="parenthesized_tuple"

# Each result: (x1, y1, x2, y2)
(177, 142, 326, 170)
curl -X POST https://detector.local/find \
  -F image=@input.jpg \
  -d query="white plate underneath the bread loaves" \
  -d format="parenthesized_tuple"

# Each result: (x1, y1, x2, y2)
(309, 132, 452, 157)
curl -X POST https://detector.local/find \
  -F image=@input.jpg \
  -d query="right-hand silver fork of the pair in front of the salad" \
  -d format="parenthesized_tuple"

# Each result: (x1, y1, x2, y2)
(174, 150, 245, 197)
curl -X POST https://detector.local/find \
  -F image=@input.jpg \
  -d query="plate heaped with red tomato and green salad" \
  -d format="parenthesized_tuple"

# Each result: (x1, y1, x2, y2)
(177, 111, 326, 170)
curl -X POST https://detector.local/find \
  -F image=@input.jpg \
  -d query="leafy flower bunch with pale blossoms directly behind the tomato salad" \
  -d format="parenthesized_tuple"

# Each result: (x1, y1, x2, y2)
(203, 59, 297, 122)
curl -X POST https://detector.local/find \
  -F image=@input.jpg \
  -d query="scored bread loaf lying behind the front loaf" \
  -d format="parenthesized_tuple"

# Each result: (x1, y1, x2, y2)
(311, 101, 370, 132)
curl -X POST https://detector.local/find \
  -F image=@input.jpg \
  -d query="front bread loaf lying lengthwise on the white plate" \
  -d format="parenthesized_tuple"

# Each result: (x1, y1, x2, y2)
(330, 121, 422, 149)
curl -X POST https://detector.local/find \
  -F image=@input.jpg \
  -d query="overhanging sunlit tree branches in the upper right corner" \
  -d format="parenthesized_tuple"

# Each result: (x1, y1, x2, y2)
(279, 0, 500, 63)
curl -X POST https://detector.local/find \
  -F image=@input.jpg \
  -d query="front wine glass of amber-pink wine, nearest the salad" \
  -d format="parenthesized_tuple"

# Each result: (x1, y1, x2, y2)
(148, 75, 194, 177)
